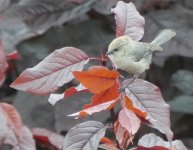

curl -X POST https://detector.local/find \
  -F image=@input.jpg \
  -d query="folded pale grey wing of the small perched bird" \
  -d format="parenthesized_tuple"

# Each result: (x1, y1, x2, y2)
(132, 41, 163, 61)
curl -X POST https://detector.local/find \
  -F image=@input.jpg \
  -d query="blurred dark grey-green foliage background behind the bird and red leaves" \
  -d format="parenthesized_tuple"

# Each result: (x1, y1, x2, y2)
(0, 0, 193, 149)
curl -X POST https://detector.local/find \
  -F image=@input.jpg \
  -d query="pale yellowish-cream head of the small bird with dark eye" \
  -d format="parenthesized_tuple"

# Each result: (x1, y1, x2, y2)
(106, 35, 131, 56)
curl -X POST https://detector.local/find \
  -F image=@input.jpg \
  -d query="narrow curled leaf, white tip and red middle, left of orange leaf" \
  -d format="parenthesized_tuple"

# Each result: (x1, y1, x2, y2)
(48, 84, 87, 105)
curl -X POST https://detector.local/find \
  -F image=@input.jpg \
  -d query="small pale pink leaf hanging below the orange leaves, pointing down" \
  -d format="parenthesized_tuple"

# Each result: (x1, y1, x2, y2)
(118, 108, 141, 135)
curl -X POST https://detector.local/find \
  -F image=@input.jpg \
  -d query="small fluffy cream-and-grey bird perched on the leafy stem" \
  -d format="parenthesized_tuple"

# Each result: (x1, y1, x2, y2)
(107, 29, 176, 78)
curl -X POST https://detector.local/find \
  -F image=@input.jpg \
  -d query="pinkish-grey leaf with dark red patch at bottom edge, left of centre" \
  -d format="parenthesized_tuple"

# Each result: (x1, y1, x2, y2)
(31, 128, 64, 149)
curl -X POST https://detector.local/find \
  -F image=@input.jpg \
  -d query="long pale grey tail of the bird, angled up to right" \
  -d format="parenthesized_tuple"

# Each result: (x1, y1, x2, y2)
(151, 29, 176, 46)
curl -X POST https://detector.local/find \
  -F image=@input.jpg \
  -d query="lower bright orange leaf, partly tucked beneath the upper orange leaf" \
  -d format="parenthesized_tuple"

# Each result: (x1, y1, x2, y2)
(84, 82, 119, 109)
